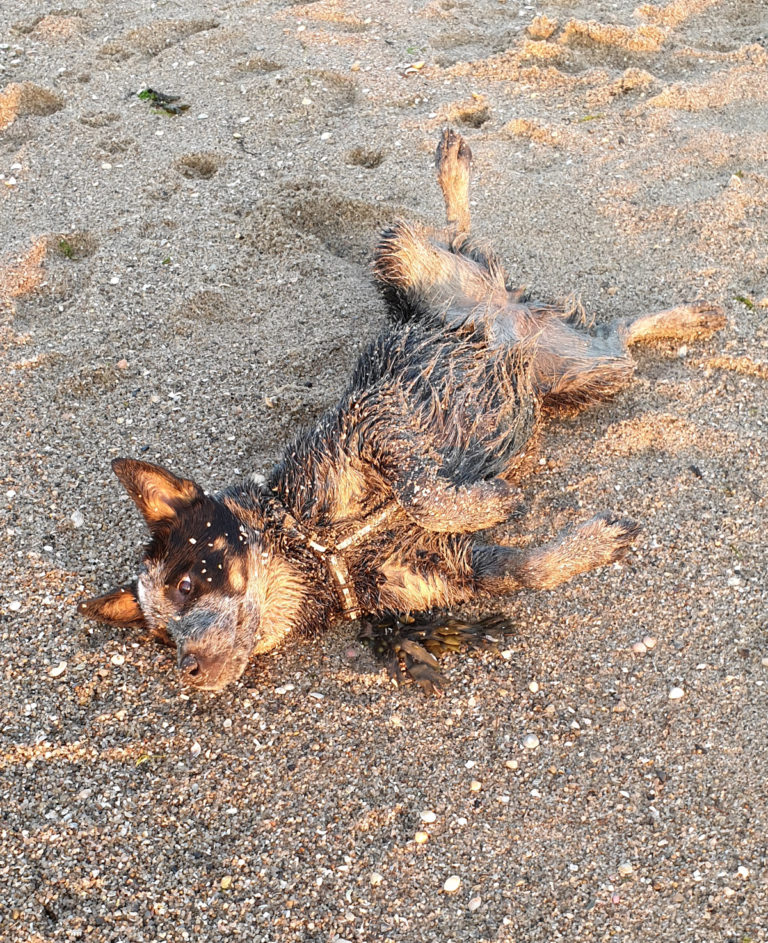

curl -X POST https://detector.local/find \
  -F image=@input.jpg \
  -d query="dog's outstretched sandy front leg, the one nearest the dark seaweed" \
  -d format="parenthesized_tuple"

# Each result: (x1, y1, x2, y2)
(472, 514, 640, 595)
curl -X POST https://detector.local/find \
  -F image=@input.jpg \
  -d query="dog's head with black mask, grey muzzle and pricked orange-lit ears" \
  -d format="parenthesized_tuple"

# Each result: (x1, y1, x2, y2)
(78, 459, 306, 691)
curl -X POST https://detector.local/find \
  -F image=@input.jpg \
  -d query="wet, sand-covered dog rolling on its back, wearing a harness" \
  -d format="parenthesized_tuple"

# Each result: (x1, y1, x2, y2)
(79, 130, 724, 691)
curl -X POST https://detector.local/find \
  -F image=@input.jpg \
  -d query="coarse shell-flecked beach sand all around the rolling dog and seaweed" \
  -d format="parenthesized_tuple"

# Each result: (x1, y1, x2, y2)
(0, 0, 768, 943)
